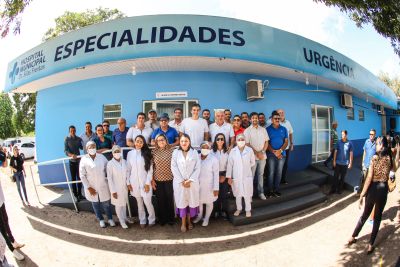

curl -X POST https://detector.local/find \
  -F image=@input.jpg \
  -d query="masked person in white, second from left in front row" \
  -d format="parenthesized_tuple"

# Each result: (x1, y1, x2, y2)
(107, 145, 132, 229)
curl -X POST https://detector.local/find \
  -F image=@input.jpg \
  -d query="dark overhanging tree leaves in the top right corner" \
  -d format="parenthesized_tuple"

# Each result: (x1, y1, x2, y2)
(314, 0, 400, 57)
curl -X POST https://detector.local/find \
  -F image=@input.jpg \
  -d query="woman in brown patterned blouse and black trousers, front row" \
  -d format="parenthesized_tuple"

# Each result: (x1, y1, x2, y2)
(151, 134, 175, 225)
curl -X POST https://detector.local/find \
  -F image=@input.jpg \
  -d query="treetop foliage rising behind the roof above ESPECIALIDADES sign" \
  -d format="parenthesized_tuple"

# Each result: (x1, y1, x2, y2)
(43, 7, 125, 41)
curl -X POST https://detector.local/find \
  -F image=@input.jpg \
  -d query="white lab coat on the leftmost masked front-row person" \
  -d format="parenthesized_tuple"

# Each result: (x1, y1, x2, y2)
(79, 153, 110, 202)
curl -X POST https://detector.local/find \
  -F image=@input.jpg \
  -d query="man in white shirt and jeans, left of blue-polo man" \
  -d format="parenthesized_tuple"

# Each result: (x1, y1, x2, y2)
(244, 112, 269, 200)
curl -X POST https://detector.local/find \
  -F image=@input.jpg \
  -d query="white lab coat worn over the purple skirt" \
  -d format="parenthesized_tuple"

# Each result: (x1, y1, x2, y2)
(171, 149, 200, 209)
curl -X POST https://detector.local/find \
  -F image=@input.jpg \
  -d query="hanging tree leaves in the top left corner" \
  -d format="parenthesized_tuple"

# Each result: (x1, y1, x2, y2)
(0, 0, 32, 38)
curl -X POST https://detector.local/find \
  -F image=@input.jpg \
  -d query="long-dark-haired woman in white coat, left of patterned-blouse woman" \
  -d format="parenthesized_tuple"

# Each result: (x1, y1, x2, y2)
(126, 135, 156, 228)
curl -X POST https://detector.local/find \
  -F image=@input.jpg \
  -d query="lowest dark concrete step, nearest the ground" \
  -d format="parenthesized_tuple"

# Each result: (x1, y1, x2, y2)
(230, 192, 327, 226)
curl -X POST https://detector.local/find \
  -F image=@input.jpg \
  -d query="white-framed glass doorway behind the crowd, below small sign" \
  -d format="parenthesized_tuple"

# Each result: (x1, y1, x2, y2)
(143, 100, 199, 120)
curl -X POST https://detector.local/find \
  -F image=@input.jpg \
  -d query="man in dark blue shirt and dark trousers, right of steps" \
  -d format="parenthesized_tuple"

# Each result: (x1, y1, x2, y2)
(329, 130, 353, 194)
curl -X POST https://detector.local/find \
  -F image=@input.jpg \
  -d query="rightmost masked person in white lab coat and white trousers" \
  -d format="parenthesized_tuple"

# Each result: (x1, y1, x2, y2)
(226, 134, 256, 217)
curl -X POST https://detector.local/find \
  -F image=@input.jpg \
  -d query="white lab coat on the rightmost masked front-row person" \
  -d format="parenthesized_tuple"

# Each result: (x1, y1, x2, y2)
(226, 146, 256, 197)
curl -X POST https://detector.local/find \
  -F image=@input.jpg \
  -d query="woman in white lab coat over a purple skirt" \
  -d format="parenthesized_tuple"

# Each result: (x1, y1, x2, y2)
(171, 133, 200, 232)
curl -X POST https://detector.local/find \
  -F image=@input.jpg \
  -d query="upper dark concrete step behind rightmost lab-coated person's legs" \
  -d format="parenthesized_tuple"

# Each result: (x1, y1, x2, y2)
(228, 184, 319, 213)
